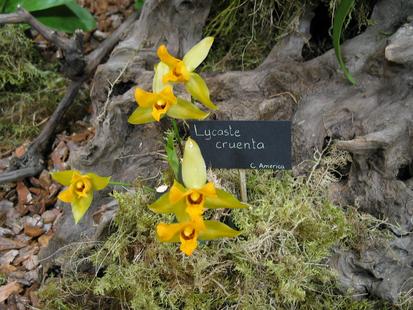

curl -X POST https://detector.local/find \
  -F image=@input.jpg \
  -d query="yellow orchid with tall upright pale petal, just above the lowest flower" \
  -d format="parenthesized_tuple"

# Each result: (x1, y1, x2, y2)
(149, 138, 247, 223)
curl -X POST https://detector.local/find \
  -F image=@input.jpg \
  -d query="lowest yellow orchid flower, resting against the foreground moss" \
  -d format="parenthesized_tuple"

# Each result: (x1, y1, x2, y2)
(156, 221, 240, 256)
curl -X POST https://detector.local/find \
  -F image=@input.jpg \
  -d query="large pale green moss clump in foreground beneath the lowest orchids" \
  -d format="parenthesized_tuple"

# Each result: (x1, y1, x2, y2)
(40, 161, 386, 309)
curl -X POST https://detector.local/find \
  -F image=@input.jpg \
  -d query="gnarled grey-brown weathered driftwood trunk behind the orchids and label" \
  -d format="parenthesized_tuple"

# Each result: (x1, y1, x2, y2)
(39, 0, 413, 302)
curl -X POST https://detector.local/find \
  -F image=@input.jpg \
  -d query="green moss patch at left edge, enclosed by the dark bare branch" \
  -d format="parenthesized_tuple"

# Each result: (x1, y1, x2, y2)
(0, 25, 66, 153)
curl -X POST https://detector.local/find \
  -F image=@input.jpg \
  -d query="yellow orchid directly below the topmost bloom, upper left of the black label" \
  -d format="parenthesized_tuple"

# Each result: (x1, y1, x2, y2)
(128, 63, 208, 125)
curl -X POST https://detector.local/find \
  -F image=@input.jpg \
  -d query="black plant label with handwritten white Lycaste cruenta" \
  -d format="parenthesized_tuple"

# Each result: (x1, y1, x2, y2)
(189, 121, 291, 170)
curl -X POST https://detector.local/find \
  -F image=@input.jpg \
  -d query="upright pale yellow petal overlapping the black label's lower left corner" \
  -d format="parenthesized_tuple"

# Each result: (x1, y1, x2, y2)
(182, 138, 206, 189)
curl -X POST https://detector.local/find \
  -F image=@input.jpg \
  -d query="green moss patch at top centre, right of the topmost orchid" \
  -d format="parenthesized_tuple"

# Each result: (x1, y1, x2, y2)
(203, 0, 304, 71)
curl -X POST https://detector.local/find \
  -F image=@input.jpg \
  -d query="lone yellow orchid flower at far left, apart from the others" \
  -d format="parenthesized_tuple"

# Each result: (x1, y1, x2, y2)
(52, 170, 110, 224)
